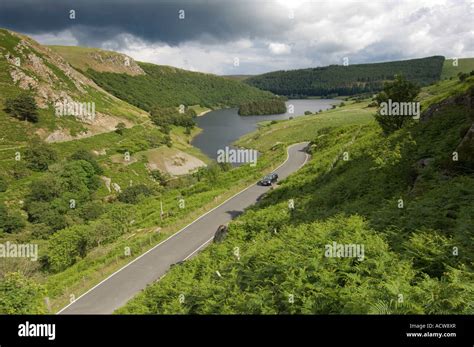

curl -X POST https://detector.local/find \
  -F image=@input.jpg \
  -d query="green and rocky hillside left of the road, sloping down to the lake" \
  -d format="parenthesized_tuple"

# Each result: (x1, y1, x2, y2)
(0, 30, 284, 314)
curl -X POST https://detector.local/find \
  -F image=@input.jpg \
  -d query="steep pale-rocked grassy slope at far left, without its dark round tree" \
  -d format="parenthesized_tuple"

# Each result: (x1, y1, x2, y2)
(0, 29, 147, 144)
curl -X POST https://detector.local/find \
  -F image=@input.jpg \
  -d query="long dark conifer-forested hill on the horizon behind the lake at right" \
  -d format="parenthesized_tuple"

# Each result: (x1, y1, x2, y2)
(244, 56, 444, 96)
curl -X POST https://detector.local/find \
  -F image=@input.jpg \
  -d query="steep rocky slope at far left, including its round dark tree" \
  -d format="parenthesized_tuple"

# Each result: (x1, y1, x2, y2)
(0, 29, 147, 148)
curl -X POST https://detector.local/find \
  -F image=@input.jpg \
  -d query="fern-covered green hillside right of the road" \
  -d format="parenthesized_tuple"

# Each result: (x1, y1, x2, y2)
(118, 77, 474, 314)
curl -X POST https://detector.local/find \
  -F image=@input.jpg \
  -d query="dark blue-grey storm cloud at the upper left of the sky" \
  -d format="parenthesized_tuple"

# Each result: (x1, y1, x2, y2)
(0, 0, 290, 45)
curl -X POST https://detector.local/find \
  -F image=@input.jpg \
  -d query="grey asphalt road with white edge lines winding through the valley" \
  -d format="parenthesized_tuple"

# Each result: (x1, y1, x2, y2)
(58, 142, 309, 314)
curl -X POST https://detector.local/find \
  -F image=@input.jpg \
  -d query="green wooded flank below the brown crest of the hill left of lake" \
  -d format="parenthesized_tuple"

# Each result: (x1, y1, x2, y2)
(86, 63, 274, 111)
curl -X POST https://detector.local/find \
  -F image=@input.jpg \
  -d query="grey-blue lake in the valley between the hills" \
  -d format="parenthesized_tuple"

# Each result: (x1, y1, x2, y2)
(191, 99, 341, 159)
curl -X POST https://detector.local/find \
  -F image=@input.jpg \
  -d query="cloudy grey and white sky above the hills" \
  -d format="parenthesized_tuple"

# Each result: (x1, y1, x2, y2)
(0, 0, 474, 75)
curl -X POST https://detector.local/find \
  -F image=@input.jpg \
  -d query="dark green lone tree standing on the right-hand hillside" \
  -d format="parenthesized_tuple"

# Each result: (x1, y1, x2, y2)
(375, 75, 420, 134)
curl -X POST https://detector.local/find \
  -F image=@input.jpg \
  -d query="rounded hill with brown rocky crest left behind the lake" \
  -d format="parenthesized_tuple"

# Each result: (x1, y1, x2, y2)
(52, 46, 275, 111)
